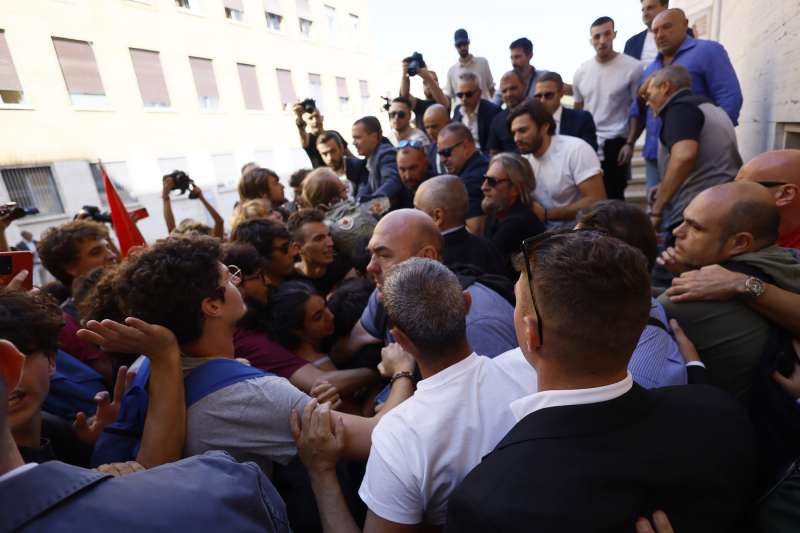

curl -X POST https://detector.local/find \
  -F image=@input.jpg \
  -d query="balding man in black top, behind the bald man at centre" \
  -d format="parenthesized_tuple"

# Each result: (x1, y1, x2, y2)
(414, 175, 508, 274)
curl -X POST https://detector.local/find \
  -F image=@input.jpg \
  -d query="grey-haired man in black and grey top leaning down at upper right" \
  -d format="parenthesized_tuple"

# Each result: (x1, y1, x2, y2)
(647, 65, 742, 236)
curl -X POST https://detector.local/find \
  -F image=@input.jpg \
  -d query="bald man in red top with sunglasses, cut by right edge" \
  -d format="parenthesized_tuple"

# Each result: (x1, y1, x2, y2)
(736, 150, 800, 249)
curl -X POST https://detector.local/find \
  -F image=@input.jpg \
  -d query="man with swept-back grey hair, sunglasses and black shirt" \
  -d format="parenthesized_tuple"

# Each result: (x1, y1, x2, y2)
(481, 152, 545, 260)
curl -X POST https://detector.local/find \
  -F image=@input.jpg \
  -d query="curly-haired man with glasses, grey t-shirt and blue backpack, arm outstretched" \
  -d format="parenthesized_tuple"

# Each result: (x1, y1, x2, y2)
(95, 236, 413, 471)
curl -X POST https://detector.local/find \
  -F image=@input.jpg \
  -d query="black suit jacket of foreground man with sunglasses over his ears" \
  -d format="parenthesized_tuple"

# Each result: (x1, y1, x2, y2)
(446, 385, 754, 533)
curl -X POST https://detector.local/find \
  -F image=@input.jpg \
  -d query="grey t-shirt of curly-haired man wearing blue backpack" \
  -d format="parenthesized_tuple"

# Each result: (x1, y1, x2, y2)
(185, 375, 311, 472)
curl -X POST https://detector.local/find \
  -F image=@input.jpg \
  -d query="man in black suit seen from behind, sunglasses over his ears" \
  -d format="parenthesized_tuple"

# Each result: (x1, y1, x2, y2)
(447, 230, 754, 533)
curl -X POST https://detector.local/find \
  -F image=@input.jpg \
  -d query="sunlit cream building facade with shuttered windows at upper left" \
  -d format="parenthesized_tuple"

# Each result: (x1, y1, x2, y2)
(0, 0, 380, 243)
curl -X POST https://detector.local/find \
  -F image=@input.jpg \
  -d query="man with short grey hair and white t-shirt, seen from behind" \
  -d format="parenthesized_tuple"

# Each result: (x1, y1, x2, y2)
(299, 257, 537, 532)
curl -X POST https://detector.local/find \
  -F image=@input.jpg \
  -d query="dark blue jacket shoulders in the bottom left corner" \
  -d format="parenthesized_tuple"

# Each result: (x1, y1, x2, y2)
(0, 452, 290, 533)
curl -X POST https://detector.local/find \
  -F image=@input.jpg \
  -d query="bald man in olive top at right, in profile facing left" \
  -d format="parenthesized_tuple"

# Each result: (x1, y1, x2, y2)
(659, 182, 800, 401)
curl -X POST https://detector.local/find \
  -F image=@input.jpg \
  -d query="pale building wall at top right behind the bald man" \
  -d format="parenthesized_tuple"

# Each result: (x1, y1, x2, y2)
(670, 0, 800, 161)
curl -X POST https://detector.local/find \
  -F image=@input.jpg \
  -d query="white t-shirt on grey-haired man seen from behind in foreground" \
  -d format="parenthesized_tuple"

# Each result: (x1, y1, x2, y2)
(359, 350, 537, 525)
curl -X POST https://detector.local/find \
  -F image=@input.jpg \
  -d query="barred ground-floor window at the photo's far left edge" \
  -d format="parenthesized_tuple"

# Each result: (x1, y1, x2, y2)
(0, 167, 64, 215)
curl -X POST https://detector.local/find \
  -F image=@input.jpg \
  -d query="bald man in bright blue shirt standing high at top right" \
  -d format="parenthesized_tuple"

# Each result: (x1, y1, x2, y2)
(619, 9, 742, 194)
